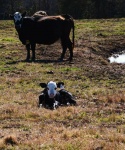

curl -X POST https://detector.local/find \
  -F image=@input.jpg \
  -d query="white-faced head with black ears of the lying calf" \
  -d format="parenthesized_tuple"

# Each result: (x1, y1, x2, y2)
(40, 81, 64, 98)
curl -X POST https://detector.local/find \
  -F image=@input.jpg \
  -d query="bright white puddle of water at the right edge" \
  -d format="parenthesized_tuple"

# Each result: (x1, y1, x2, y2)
(109, 53, 125, 64)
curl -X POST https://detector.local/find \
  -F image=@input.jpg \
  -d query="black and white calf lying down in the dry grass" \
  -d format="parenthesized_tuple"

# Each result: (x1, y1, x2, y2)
(39, 81, 76, 109)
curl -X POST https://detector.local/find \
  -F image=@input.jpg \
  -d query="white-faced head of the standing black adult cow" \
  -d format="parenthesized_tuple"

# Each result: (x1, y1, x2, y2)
(10, 12, 26, 30)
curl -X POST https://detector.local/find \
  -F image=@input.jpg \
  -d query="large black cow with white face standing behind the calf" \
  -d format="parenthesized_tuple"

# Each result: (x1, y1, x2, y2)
(10, 12, 74, 61)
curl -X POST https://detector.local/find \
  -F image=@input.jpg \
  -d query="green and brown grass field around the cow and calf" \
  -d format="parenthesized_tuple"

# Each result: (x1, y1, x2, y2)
(0, 18, 125, 150)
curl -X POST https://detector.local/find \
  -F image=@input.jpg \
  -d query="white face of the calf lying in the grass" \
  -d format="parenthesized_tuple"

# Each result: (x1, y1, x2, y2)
(47, 81, 57, 98)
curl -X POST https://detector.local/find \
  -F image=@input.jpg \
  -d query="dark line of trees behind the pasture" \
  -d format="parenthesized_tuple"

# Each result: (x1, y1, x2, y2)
(0, 0, 125, 19)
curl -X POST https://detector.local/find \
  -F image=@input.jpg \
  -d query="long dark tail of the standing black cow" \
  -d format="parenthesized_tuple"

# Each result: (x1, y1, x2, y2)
(62, 14, 75, 48)
